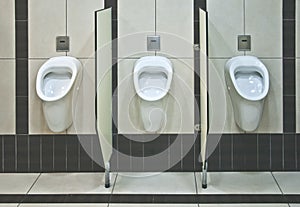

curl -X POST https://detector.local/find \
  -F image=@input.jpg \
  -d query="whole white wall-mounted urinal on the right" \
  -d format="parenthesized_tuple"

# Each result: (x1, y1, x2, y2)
(225, 56, 269, 131)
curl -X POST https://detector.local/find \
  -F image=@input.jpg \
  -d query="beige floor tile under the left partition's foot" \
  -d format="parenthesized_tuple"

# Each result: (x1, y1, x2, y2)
(29, 173, 115, 194)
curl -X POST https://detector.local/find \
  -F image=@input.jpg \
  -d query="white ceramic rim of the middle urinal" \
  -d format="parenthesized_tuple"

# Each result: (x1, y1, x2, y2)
(133, 56, 173, 101)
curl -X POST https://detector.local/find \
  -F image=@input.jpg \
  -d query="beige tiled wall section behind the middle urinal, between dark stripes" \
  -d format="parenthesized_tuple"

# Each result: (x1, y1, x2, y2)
(117, 0, 195, 134)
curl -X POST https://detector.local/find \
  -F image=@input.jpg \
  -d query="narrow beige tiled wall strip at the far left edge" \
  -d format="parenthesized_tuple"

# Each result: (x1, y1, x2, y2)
(0, 0, 15, 134)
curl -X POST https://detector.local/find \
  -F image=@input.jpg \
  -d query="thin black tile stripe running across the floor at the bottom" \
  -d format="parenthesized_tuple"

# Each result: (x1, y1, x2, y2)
(0, 194, 300, 204)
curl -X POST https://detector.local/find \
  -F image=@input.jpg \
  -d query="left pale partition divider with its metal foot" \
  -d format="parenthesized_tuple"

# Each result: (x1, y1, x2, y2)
(96, 8, 112, 187)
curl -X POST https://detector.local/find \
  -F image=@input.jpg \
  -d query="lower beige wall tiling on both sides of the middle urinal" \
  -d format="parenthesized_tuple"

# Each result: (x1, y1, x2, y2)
(118, 59, 195, 134)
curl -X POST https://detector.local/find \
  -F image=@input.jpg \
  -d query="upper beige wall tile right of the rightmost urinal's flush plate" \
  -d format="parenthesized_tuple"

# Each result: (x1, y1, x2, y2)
(245, 0, 282, 58)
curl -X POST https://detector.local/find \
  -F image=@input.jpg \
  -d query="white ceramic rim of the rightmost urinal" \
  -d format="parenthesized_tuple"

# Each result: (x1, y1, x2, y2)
(225, 56, 270, 101)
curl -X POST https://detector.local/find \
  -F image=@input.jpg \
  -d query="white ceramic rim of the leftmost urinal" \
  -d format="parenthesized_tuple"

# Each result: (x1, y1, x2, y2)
(36, 56, 82, 102)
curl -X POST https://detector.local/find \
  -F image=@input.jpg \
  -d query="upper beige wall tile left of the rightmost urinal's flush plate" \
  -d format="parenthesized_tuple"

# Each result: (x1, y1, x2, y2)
(207, 0, 244, 58)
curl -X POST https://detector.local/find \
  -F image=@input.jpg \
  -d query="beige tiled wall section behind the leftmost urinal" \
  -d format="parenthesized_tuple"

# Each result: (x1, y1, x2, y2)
(28, 0, 104, 134)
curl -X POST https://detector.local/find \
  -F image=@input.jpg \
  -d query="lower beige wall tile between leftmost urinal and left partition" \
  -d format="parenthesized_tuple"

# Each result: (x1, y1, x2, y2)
(67, 59, 96, 134)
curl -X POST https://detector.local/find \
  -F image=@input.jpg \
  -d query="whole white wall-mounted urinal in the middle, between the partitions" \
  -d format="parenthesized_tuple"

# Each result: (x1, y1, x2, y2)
(133, 56, 173, 132)
